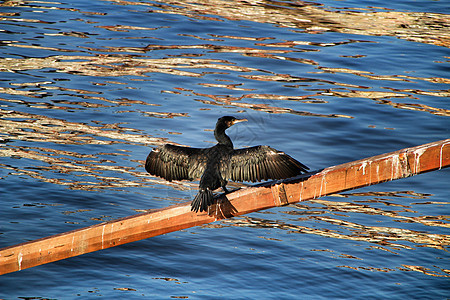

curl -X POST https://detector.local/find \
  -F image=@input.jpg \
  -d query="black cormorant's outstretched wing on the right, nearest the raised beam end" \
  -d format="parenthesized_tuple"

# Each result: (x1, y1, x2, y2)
(221, 146, 309, 182)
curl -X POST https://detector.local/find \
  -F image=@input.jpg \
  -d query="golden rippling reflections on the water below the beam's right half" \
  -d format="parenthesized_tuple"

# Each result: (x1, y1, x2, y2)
(215, 191, 450, 277)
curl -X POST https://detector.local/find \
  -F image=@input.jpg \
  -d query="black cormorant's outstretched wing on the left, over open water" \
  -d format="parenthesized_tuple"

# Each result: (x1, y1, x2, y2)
(145, 144, 206, 181)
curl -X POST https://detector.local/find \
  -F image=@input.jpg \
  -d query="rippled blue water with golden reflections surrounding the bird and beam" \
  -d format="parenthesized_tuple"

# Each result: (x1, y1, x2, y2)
(0, 0, 450, 299)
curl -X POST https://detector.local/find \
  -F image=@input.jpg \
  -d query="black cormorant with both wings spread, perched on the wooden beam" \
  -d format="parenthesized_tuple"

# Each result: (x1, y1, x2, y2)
(145, 116, 309, 212)
